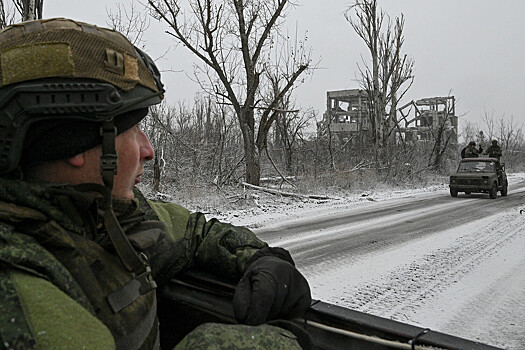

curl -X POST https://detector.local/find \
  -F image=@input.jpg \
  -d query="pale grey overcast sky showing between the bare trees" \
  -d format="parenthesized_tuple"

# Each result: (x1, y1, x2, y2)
(44, 0, 525, 131)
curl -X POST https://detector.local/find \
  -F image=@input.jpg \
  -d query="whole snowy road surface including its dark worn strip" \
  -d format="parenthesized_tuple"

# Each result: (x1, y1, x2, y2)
(224, 176, 525, 349)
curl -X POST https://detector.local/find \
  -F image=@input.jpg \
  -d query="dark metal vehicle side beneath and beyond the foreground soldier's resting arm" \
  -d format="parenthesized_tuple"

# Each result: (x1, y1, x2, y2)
(158, 273, 497, 350)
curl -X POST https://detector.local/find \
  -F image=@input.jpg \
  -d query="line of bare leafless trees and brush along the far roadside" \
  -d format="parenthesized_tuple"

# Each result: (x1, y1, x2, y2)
(0, 0, 523, 194)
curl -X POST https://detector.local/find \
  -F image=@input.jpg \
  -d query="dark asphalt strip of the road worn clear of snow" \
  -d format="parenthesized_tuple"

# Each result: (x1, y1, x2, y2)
(252, 182, 525, 268)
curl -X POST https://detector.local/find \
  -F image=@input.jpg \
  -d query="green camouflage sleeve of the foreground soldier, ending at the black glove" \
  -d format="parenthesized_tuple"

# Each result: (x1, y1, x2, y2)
(139, 199, 268, 283)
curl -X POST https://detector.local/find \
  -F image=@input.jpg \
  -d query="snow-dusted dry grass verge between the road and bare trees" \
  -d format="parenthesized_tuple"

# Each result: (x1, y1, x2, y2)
(139, 169, 448, 214)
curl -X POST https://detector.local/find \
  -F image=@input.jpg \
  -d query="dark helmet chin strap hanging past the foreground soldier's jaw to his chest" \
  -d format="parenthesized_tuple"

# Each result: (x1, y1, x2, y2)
(100, 119, 157, 313)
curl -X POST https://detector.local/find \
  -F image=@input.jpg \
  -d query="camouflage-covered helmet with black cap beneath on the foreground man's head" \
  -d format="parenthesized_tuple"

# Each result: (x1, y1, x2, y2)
(0, 18, 164, 173)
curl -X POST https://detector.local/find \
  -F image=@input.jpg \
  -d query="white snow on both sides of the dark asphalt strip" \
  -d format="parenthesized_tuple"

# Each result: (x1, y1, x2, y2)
(212, 174, 525, 349)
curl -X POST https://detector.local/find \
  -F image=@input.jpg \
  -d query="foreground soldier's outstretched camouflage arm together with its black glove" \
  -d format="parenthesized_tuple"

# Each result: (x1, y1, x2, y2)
(135, 190, 311, 325)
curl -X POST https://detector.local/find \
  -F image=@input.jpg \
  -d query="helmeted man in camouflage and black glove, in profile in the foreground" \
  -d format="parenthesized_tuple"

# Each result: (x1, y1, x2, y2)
(0, 19, 311, 349)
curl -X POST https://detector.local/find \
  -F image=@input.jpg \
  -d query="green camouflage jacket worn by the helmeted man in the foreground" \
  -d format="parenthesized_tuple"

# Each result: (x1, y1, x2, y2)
(0, 179, 267, 349)
